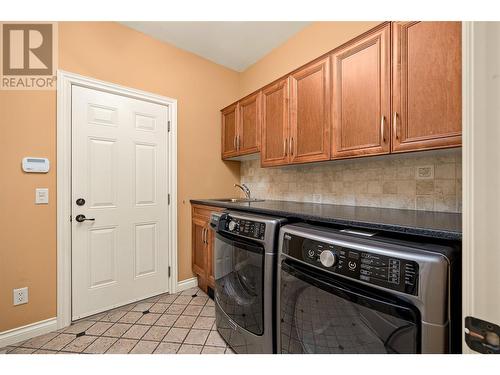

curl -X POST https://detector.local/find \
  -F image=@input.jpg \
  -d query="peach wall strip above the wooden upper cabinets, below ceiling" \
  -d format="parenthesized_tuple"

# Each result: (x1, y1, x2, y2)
(238, 22, 380, 97)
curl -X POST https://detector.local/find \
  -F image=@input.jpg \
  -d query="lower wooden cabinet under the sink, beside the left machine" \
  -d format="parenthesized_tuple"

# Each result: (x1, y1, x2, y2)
(191, 205, 222, 292)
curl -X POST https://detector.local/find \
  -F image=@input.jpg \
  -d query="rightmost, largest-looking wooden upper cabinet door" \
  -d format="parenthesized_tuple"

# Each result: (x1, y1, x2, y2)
(392, 22, 462, 152)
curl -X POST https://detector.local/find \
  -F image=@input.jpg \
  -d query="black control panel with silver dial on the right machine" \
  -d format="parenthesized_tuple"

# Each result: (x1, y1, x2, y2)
(282, 233, 419, 295)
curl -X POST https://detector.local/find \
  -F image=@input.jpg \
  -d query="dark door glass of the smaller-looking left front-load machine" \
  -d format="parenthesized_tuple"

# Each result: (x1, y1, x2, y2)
(213, 233, 264, 335)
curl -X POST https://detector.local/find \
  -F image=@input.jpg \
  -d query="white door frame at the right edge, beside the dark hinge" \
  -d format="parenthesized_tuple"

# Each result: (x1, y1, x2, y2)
(462, 21, 500, 353)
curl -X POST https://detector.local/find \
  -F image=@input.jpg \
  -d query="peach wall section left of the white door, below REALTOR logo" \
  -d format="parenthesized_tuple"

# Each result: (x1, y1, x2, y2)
(0, 91, 56, 332)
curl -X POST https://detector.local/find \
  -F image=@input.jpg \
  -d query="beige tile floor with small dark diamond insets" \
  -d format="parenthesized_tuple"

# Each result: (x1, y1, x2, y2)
(0, 288, 233, 354)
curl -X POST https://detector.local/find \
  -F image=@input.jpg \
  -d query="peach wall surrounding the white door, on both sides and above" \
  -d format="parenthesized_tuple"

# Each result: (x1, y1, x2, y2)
(0, 22, 239, 332)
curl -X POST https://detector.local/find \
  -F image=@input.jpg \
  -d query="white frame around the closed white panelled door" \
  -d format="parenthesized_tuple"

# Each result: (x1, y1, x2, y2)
(57, 70, 177, 328)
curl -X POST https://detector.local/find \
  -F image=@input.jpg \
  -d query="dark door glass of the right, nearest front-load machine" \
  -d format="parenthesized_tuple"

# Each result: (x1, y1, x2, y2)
(280, 261, 420, 353)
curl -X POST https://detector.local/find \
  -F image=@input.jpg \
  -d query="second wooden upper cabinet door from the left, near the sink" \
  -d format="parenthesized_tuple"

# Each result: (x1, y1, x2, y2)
(236, 92, 261, 155)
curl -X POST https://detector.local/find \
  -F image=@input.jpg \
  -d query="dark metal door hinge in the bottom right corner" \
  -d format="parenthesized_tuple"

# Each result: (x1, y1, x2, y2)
(465, 316, 500, 354)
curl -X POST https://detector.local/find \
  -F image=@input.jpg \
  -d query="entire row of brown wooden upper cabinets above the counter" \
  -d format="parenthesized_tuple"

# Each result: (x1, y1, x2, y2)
(222, 22, 462, 167)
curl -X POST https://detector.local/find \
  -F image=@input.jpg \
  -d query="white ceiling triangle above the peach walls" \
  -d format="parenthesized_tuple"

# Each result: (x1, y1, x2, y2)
(121, 21, 309, 72)
